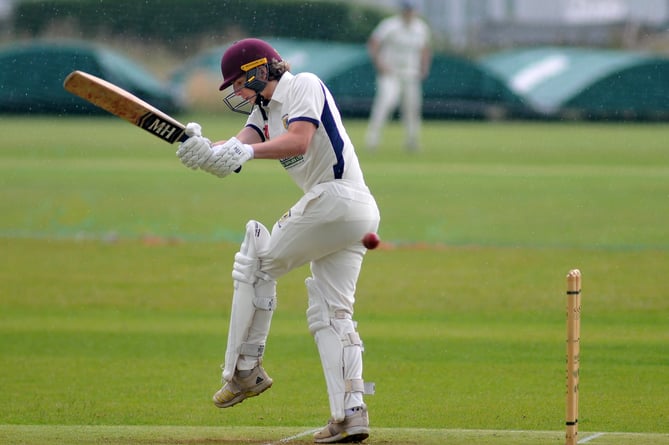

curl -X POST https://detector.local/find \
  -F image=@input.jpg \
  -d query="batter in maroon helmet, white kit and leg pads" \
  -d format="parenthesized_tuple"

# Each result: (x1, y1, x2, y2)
(177, 39, 379, 443)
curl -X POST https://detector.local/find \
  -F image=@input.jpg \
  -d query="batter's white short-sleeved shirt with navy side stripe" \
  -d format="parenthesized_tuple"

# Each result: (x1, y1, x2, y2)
(246, 72, 366, 193)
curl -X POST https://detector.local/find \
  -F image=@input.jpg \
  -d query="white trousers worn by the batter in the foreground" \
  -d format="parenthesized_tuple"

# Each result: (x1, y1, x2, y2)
(260, 180, 380, 315)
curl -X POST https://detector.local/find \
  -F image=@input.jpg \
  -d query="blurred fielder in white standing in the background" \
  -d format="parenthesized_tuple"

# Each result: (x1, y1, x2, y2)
(366, 0, 431, 151)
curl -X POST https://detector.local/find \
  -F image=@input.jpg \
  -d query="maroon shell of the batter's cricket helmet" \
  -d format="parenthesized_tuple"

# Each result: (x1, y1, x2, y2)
(219, 39, 282, 91)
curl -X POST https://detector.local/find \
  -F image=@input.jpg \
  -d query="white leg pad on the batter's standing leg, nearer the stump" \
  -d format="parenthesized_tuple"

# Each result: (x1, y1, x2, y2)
(305, 278, 365, 422)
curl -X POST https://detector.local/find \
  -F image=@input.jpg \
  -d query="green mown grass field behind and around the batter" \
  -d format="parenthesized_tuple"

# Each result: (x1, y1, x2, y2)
(0, 115, 669, 445)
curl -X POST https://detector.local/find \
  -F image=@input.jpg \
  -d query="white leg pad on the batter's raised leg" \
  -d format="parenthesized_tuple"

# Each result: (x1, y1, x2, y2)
(223, 221, 276, 381)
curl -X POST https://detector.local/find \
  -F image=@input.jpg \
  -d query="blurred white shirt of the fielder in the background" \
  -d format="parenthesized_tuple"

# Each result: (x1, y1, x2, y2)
(371, 15, 430, 78)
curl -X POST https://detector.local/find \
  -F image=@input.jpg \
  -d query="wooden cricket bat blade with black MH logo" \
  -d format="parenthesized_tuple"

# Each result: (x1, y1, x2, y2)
(63, 71, 188, 144)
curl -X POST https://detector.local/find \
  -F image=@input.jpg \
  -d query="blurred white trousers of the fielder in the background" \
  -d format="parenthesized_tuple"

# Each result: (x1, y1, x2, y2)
(366, 74, 423, 149)
